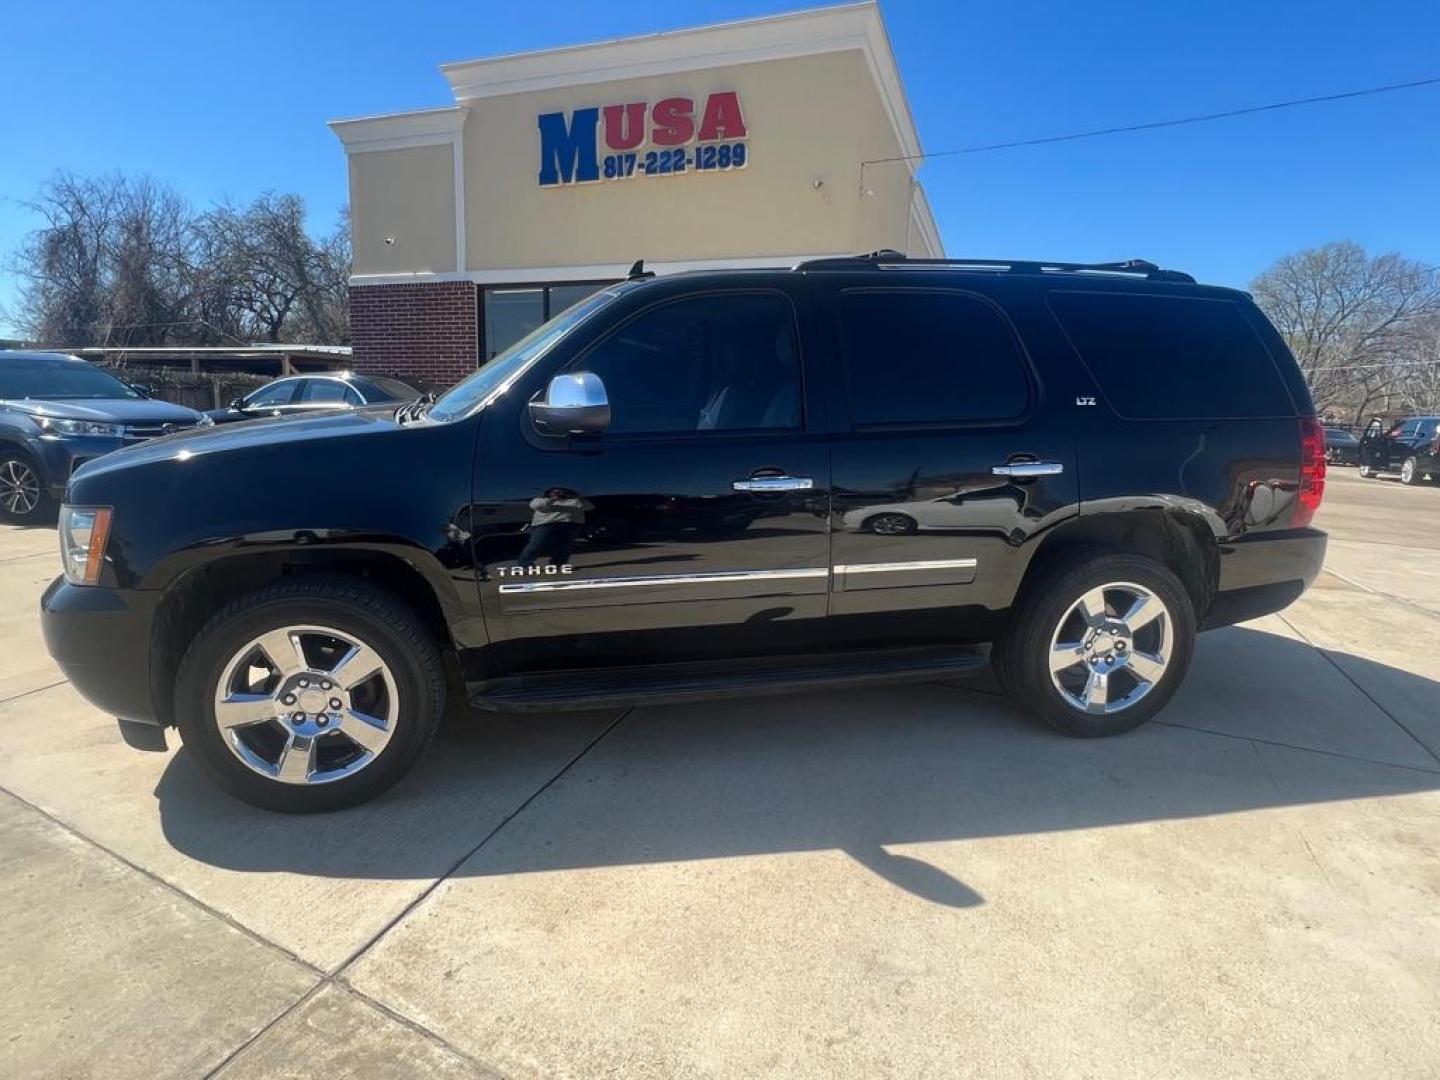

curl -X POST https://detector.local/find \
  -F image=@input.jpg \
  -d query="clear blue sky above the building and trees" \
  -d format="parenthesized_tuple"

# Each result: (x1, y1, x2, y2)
(0, 0, 1440, 336)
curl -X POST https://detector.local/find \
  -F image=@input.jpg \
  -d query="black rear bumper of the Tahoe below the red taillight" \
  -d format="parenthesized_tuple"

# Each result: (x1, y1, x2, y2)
(1201, 528, 1329, 629)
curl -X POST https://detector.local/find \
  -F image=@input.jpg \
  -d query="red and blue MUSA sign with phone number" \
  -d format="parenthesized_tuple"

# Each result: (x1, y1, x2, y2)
(539, 91, 750, 187)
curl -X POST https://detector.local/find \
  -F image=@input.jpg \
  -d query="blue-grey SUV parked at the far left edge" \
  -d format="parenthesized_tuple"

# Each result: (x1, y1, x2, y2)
(0, 350, 209, 523)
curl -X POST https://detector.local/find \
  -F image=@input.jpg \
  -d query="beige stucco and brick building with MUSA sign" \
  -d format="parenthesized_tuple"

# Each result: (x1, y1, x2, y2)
(330, 0, 943, 386)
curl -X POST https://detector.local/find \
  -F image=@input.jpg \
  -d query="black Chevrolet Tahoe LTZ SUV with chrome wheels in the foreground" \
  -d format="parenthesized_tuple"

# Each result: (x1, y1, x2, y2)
(42, 252, 1325, 811)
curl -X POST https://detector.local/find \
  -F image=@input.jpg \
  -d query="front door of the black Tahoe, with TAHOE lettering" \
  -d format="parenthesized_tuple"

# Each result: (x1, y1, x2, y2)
(469, 288, 829, 672)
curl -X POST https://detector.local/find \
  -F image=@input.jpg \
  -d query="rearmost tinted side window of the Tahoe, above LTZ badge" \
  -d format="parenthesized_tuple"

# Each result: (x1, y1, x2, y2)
(1050, 292, 1295, 420)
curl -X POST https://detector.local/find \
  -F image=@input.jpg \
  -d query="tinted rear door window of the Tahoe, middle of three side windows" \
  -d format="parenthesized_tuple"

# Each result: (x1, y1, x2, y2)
(840, 292, 1030, 426)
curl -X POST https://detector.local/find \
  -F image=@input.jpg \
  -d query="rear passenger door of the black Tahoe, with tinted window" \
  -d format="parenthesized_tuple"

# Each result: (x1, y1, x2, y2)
(829, 284, 1079, 639)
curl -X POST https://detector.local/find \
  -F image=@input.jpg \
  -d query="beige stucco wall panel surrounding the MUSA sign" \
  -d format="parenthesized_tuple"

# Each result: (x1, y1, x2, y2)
(459, 52, 910, 269)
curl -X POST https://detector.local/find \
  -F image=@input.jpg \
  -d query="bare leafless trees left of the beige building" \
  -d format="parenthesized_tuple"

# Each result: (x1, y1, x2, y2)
(12, 174, 350, 346)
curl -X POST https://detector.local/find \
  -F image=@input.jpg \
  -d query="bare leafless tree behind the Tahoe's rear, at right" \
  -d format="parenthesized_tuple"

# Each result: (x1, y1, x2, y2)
(1250, 240, 1440, 423)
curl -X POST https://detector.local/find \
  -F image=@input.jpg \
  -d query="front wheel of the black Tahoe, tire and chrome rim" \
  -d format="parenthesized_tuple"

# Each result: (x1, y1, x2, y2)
(174, 575, 445, 814)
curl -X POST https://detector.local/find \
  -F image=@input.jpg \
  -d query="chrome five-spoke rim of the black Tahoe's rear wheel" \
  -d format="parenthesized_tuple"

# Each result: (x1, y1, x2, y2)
(1050, 582, 1174, 716)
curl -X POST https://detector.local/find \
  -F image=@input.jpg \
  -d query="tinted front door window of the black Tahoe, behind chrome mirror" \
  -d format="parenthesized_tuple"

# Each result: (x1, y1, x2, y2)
(572, 292, 801, 435)
